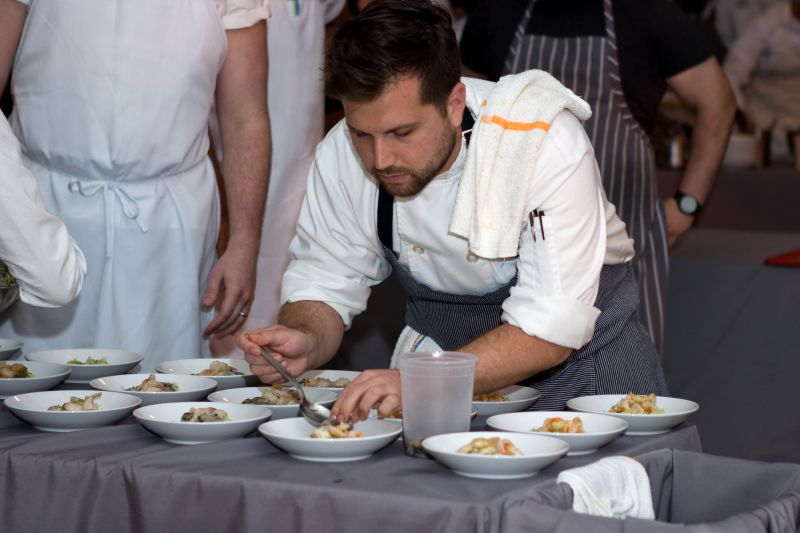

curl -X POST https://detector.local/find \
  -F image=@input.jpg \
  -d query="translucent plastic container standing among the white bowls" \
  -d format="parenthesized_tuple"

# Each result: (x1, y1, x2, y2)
(397, 352, 478, 458)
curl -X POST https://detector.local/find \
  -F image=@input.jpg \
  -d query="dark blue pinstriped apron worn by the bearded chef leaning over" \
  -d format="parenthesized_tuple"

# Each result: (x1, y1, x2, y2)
(377, 112, 667, 410)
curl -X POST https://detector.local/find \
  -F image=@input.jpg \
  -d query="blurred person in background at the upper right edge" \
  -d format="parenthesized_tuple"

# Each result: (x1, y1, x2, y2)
(724, 0, 800, 160)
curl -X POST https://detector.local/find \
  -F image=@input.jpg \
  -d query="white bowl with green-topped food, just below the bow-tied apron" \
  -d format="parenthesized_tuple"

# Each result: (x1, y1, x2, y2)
(25, 348, 144, 383)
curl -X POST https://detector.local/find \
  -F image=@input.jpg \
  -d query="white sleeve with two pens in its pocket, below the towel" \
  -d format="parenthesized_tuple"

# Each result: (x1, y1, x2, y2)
(502, 112, 606, 349)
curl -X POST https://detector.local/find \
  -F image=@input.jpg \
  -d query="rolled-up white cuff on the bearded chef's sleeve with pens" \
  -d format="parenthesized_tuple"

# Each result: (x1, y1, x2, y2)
(501, 294, 600, 350)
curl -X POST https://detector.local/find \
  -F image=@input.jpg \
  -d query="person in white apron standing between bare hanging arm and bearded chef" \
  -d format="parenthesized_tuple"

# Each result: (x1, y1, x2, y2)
(211, 0, 345, 356)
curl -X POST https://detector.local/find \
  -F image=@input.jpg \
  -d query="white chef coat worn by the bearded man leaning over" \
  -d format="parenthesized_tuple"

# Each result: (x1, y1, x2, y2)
(281, 79, 633, 348)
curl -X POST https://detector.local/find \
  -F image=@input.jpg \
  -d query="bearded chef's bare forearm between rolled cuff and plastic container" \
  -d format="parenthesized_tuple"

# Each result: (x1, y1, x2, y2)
(458, 324, 572, 394)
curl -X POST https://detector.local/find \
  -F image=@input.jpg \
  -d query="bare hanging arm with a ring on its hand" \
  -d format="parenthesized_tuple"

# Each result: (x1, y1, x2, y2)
(203, 22, 270, 336)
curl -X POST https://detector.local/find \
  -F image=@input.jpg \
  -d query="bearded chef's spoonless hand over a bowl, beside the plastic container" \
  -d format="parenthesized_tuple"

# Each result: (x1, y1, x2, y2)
(331, 370, 401, 422)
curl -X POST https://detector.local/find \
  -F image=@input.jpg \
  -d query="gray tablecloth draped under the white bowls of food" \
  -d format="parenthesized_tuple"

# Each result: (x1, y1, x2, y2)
(0, 408, 700, 533)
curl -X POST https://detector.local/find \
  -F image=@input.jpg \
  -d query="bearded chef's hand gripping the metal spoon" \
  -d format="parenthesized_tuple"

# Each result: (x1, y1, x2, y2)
(236, 326, 315, 383)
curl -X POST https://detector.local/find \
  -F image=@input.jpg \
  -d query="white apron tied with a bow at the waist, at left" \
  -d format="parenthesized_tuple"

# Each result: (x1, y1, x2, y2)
(0, 0, 227, 371)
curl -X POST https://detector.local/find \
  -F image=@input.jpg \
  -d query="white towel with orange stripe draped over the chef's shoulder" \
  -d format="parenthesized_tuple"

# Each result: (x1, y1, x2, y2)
(450, 70, 592, 259)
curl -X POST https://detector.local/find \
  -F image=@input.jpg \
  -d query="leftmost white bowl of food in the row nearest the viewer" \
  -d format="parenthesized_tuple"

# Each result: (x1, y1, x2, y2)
(5, 390, 139, 431)
